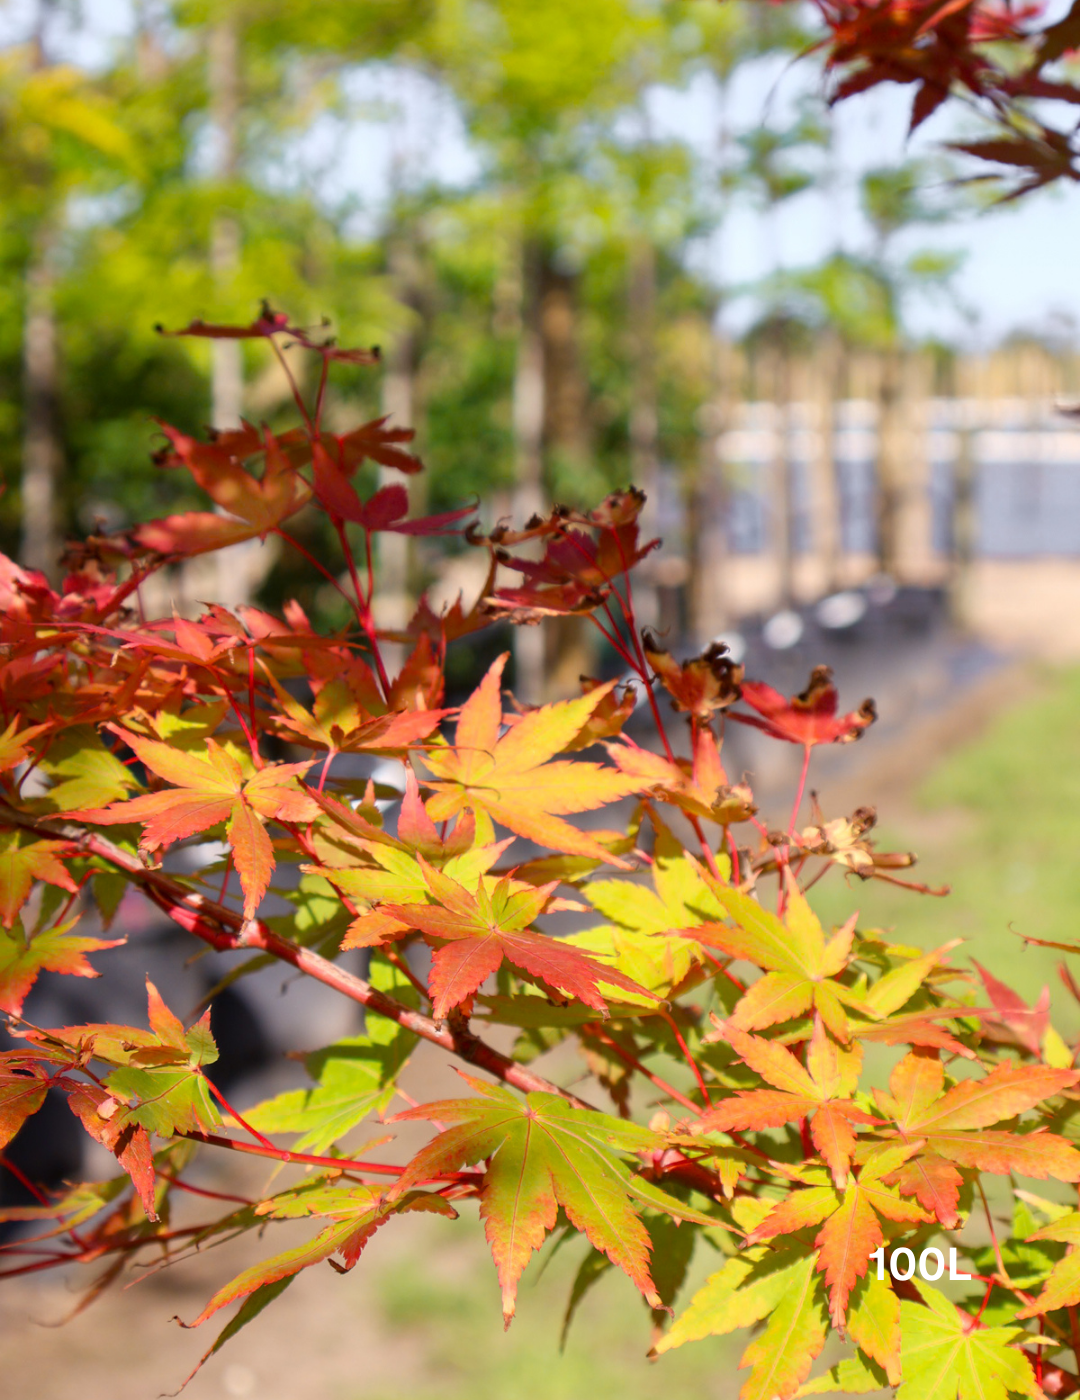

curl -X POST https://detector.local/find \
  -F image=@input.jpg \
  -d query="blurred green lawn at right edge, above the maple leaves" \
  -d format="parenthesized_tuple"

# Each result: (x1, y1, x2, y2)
(815, 669, 1080, 1036)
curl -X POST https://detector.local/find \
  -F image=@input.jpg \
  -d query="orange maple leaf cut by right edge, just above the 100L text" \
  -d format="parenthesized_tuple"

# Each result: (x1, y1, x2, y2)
(874, 1049, 1080, 1229)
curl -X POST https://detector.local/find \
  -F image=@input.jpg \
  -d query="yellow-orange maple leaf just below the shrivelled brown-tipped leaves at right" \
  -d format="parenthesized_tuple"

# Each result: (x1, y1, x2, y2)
(684, 872, 860, 1043)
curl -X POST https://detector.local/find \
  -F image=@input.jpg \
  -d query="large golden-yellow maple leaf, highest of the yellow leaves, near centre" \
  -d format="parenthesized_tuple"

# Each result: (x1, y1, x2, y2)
(423, 652, 642, 865)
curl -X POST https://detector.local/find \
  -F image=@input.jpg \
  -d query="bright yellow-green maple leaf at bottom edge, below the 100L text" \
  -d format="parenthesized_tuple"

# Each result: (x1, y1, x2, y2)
(896, 1280, 1042, 1400)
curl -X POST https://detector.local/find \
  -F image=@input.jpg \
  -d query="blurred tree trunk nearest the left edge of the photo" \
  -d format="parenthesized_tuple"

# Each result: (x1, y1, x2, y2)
(22, 223, 63, 582)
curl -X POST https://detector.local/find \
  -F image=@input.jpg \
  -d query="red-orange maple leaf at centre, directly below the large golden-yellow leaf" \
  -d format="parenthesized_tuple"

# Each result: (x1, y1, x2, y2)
(380, 855, 649, 1021)
